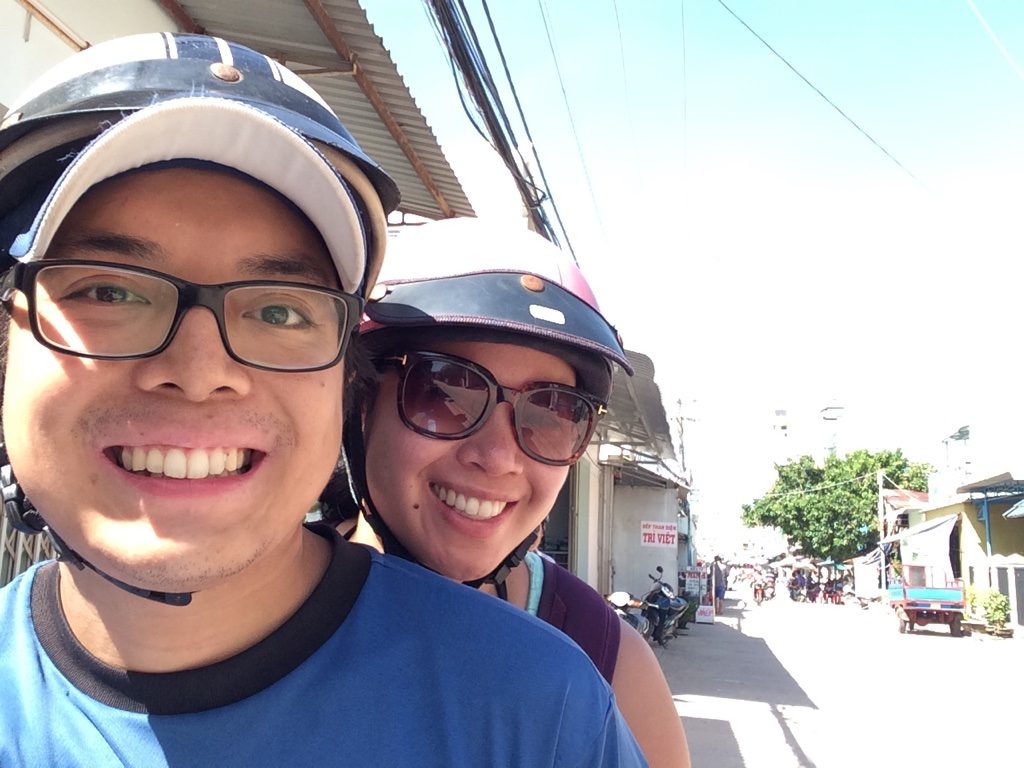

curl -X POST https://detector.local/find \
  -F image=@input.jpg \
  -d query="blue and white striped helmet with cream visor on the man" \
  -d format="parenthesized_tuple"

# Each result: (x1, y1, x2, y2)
(0, 33, 398, 296)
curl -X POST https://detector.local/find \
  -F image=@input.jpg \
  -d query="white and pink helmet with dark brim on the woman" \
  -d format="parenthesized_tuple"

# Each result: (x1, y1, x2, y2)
(359, 218, 633, 401)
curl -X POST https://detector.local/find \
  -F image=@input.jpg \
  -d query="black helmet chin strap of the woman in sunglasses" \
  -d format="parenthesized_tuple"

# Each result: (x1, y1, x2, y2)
(342, 417, 537, 600)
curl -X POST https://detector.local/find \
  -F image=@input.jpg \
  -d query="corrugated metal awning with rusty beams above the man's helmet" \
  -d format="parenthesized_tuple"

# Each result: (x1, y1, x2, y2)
(159, 0, 473, 219)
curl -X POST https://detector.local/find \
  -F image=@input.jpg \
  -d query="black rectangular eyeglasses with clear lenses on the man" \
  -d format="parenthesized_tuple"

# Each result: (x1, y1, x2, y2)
(0, 259, 362, 373)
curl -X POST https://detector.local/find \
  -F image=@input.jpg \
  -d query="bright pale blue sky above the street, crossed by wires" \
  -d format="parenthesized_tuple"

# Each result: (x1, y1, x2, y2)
(364, 0, 1024, 552)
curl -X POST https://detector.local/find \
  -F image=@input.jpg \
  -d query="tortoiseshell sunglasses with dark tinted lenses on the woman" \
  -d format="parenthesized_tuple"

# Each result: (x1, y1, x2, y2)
(379, 352, 605, 466)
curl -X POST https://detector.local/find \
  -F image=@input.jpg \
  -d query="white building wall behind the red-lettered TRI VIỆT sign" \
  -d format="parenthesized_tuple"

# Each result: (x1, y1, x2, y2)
(611, 485, 679, 595)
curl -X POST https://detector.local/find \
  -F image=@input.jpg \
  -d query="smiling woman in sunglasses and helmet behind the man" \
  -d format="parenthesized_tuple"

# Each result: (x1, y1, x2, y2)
(345, 219, 689, 766)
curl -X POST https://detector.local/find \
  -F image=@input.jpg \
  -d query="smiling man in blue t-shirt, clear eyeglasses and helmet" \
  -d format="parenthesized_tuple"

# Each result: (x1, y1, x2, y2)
(0, 34, 644, 766)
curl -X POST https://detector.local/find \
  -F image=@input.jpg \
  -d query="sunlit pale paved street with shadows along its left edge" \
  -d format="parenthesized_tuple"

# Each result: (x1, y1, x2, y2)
(655, 593, 1024, 768)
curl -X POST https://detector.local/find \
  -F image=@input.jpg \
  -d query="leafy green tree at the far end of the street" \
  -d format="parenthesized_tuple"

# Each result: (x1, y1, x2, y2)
(742, 450, 931, 560)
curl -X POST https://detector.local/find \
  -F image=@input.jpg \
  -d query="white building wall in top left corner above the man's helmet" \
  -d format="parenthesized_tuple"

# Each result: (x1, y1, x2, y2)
(0, 0, 178, 108)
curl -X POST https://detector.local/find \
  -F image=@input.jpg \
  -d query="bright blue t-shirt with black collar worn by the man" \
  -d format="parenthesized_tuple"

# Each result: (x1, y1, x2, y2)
(0, 530, 646, 768)
